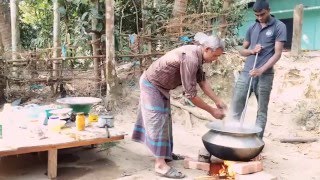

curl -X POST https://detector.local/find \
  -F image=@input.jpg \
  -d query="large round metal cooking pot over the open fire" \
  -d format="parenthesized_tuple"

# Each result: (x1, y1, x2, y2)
(202, 121, 264, 161)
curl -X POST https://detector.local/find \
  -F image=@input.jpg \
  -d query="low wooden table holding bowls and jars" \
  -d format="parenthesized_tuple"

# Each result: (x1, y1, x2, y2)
(0, 125, 125, 179)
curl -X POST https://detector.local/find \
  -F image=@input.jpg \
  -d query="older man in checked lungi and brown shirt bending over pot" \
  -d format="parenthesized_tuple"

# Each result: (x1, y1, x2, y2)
(132, 33, 226, 178)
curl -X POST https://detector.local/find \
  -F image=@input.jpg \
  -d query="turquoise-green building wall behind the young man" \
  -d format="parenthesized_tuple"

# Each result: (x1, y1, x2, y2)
(239, 0, 320, 50)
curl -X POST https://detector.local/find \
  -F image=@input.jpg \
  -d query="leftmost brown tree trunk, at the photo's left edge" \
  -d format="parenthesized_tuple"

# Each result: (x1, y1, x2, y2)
(0, 3, 11, 51)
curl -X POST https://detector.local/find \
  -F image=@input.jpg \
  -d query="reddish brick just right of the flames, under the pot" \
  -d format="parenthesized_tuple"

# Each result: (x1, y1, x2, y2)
(232, 161, 263, 174)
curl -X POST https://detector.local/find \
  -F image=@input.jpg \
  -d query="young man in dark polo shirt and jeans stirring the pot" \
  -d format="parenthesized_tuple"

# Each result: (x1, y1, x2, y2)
(232, 0, 287, 139)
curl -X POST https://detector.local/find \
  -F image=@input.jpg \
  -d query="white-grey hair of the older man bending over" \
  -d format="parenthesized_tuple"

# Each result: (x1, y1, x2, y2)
(194, 32, 224, 50)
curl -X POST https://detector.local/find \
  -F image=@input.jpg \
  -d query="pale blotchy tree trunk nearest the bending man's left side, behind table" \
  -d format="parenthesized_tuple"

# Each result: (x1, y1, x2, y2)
(105, 0, 122, 110)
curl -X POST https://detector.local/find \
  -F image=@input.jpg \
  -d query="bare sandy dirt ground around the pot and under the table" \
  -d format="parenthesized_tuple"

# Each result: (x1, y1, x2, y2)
(0, 53, 320, 180)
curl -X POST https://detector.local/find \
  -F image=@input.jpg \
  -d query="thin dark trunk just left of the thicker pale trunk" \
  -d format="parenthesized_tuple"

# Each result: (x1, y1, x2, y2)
(91, 0, 101, 93)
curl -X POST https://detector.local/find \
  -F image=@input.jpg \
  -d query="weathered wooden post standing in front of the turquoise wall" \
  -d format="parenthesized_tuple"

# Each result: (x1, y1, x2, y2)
(291, 4, 303, 56)
